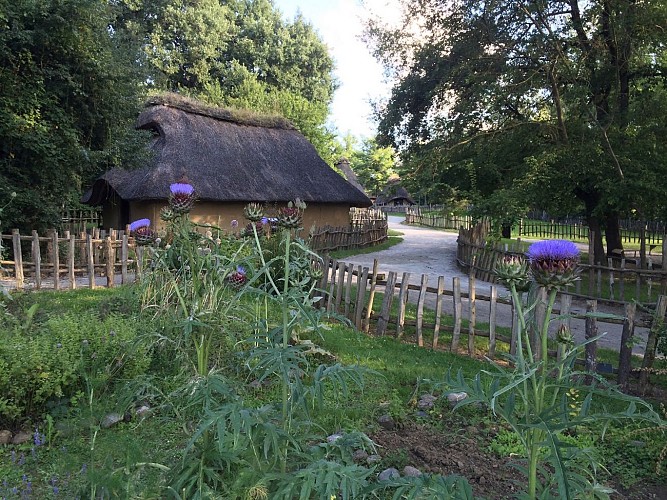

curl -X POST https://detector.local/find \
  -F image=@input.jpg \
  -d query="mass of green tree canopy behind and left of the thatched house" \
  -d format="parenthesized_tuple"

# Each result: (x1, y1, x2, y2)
(0, 0, 336, 229)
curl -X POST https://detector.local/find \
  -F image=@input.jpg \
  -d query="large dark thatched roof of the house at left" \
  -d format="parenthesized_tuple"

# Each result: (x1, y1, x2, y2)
(82, 94, 371, 207)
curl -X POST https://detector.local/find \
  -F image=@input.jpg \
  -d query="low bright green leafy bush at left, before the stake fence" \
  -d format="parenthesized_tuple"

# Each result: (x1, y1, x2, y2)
(0, 313, 150, 422)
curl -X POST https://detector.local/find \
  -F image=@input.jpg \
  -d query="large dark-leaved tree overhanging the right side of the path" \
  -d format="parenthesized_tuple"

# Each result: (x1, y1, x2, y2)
(368, 0, 667, 260)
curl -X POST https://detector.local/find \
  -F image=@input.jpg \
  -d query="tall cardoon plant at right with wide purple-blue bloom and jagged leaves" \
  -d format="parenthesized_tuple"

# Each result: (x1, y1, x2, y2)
(446, 240, 659, 499)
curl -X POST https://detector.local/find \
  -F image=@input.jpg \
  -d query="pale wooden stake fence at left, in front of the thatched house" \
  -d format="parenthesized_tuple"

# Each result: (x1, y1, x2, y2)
(0, 229, 141, 290)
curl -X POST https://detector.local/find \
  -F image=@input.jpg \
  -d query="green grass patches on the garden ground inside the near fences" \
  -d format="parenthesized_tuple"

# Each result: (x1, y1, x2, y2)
(0, 286, 659, 499)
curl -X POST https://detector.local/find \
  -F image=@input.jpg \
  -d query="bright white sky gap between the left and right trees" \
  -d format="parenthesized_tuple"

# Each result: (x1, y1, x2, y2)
(274, 0, 398, 140)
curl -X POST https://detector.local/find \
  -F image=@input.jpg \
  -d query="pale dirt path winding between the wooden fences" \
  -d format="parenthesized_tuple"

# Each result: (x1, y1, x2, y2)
(344, 215, 648, 354)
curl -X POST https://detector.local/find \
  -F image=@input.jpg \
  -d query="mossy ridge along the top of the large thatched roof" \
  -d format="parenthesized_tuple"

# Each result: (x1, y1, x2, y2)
(145, 92, 296, 130)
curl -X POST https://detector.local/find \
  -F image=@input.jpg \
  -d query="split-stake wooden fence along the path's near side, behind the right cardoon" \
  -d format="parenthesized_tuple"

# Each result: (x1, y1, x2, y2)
(318, 257, 667, 387)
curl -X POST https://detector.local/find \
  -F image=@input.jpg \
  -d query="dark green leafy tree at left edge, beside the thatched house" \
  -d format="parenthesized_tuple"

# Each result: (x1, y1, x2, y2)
(0, 0, 149, 229)
